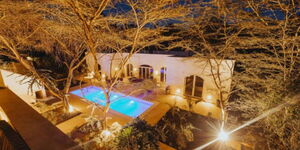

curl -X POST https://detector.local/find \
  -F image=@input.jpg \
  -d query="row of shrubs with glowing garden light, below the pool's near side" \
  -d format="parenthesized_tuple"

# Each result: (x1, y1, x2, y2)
(71, 117, 159, 150)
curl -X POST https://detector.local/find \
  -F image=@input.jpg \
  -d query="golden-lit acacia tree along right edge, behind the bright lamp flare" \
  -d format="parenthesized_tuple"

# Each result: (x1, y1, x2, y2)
(229, 0, 300, 149)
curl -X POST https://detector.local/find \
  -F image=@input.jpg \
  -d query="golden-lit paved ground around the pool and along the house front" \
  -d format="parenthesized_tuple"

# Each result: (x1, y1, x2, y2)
(8, 77, 225, 149)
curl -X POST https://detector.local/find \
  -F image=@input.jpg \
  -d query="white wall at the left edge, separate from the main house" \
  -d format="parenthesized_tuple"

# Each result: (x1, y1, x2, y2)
(0, 69, 45, 103)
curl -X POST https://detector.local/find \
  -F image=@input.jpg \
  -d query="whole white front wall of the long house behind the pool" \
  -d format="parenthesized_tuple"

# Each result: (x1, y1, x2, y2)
(89, 53, 234, 102)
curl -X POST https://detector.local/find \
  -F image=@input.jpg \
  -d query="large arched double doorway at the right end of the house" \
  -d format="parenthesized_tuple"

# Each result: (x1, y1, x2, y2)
(184, 75, 204, 97)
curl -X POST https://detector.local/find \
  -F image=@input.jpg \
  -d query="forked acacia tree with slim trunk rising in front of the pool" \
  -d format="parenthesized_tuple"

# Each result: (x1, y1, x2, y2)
(54, 0, 187, 128)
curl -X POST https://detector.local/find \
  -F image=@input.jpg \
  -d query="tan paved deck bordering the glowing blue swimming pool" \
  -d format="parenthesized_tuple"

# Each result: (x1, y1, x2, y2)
(57, 84, 170, 133)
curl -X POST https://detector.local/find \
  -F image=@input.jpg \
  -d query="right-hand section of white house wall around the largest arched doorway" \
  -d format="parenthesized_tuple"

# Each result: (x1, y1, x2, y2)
(166, 57, 234, 102)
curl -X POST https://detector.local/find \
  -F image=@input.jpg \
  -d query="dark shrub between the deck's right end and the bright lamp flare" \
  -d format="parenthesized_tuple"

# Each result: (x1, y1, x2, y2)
(156, 107, 194, 149)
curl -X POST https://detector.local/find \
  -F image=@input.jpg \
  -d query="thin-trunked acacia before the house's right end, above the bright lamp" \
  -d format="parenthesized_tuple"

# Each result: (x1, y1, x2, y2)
(170, 1, 242, 130)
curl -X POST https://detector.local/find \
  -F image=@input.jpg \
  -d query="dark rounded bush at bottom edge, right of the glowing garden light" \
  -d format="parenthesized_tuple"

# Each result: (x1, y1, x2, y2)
(116, 118, 159, 150)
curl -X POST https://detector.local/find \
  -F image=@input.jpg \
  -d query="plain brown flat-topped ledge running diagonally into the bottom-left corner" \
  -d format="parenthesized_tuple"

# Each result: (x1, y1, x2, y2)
(0, 88, 76, 150)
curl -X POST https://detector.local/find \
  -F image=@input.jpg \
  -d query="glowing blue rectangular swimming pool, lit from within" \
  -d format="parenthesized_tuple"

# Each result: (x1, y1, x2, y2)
(71, 86, 153, 118)
